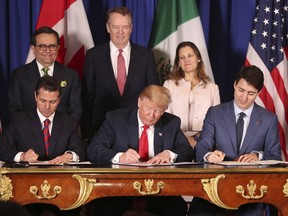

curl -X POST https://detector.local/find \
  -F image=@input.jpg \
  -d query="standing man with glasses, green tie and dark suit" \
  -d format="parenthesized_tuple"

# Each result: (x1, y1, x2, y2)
(8, 27, 82, 123)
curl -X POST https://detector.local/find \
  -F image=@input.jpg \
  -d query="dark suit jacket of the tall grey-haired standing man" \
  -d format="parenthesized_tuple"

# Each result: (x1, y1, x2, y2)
(83, 42, 159, 135)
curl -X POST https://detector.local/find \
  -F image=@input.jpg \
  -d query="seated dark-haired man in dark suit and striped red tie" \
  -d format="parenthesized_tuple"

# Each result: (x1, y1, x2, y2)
(0, 75, 86, 164)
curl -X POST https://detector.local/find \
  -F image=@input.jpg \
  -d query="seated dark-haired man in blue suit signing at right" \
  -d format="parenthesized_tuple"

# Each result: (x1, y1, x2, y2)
(189, 66, 281, 216)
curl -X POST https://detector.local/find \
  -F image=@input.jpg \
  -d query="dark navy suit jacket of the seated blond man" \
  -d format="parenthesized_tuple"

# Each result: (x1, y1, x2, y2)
(87, 107, 193, 164)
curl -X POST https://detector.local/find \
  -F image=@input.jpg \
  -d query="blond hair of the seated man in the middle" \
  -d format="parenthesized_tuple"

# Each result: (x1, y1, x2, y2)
(139, 85, 171, 110)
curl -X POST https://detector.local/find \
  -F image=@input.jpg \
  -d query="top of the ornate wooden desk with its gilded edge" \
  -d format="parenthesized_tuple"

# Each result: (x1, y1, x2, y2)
(0, 163, 288, 174)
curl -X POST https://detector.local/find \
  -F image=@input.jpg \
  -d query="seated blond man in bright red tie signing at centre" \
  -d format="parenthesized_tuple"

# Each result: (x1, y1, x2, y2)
(87, 85, 193, 216)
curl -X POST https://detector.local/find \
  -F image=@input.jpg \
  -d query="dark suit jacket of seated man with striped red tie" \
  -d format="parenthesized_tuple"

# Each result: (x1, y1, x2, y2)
(0, 110, 86, 161)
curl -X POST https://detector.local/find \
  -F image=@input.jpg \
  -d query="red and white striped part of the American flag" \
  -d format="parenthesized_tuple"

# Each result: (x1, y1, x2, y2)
(245, 43, 288, 161)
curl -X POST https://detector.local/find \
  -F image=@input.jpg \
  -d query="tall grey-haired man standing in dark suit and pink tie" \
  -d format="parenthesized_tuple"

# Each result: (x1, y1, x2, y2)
(83, 7, 159, 138)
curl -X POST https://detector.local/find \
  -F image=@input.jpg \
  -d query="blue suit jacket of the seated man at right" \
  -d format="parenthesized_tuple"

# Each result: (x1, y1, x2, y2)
(195, 101, 281, 161)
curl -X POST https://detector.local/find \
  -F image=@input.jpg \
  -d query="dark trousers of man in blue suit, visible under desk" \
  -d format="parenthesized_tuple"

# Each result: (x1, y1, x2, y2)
(188, 197, 264, 216)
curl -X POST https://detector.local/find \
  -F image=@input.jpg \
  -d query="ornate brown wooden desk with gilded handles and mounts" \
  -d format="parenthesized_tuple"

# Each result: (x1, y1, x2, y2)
(0, 164, 288, 216)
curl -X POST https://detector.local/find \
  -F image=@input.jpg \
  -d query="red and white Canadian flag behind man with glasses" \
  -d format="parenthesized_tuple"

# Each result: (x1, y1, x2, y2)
(26, 0, 94, 79)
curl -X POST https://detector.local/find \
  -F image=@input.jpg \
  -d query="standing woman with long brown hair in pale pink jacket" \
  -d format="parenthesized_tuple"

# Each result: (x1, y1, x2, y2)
(164, 41, 220, 147)
